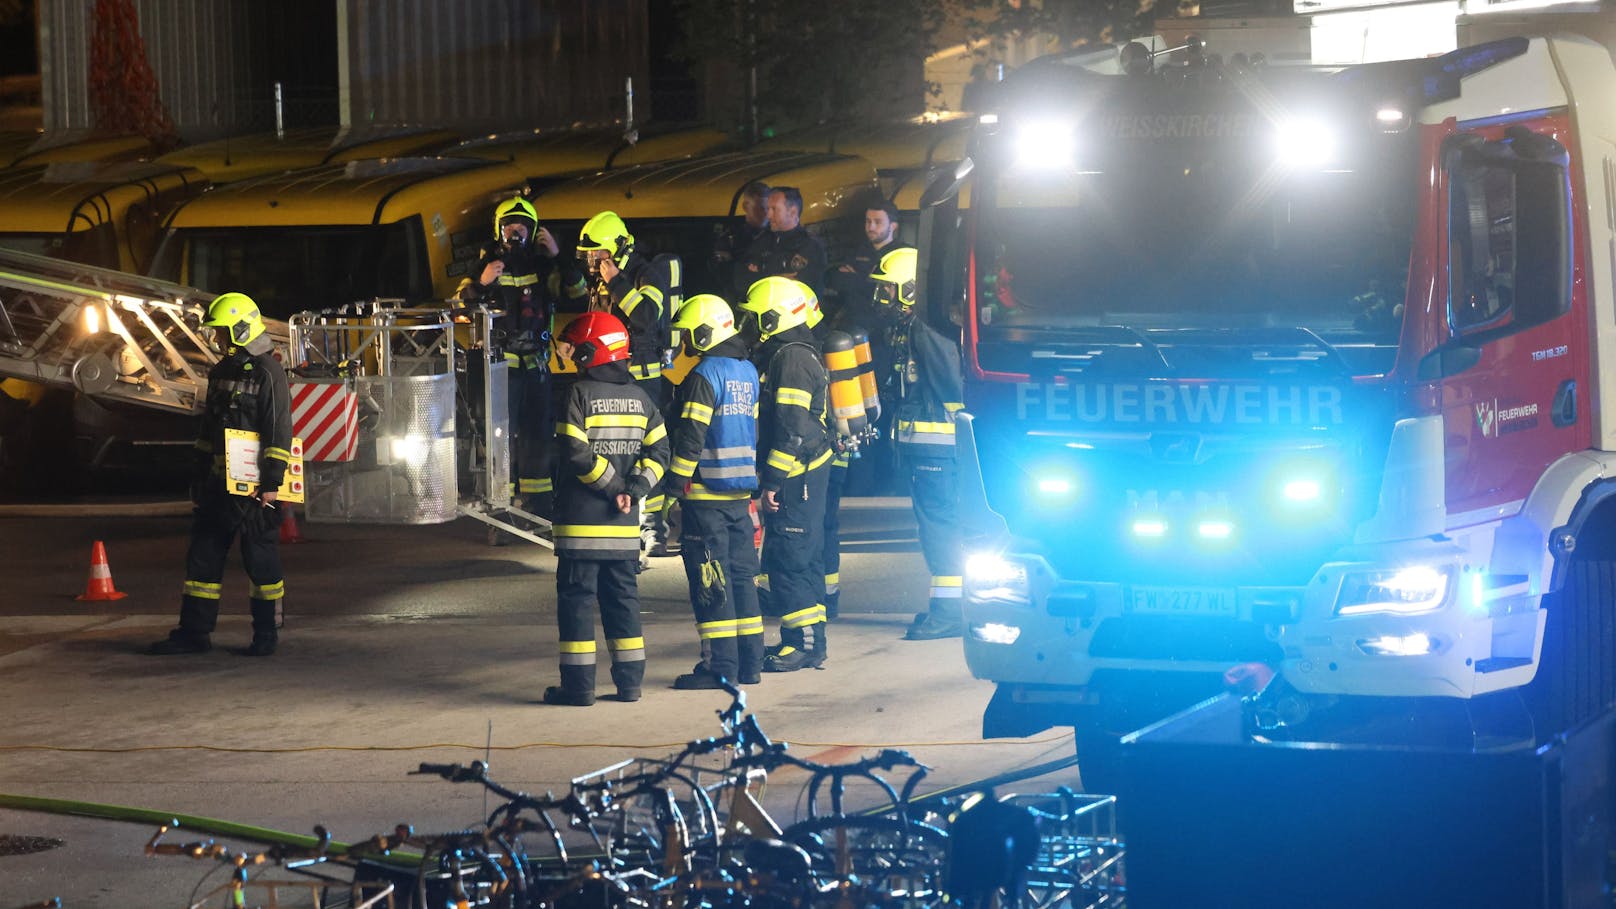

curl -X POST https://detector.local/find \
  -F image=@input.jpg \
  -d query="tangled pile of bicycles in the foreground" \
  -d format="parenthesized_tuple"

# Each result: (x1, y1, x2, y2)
(147, 687, 1125, 909)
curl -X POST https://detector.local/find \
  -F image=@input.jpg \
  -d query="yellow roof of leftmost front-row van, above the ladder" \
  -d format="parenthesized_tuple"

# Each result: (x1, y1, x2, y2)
(0, 162, 207, 233)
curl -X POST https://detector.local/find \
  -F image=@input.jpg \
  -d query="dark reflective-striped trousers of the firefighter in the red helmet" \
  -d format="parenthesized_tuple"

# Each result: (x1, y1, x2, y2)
(556, 556, 645, 694)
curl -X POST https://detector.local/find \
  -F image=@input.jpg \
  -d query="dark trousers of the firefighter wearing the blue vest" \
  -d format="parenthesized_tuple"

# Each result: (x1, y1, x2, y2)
(679, 498, 763, 683)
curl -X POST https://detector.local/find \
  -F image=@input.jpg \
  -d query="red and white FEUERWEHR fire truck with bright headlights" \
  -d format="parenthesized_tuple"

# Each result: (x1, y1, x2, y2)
(928, 13, 1616, 750)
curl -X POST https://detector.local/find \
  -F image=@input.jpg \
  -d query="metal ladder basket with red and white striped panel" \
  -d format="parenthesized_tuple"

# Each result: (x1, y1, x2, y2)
(291, 301, 459, 524)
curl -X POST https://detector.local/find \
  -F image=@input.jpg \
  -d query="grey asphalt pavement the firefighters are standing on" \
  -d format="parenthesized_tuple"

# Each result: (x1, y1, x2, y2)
(0, 500, 1079, 907)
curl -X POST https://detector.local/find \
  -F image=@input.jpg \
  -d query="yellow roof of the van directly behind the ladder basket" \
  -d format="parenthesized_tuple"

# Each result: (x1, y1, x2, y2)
(170, 157, 522, 228)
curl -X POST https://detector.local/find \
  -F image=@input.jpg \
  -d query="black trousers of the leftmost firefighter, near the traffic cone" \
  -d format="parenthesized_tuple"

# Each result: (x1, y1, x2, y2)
(179, 477, 286, 637)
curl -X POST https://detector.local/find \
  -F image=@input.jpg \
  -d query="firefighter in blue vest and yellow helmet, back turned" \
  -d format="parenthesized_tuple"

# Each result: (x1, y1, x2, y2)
(667, 294, 763, 689)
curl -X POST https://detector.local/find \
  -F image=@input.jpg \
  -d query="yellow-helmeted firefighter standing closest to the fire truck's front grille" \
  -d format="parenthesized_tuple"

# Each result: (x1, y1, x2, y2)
(871, 249, 965, 641)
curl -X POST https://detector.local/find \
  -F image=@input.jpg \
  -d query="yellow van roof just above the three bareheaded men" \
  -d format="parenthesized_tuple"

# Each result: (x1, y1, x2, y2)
(533, 150, 876, 223)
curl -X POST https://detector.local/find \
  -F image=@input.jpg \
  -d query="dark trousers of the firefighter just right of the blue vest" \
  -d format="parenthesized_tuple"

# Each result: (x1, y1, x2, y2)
(763, 461, 831, 657)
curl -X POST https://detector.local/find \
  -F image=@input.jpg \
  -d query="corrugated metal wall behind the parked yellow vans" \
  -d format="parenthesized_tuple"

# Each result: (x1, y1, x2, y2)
(39, 0, 650, 141)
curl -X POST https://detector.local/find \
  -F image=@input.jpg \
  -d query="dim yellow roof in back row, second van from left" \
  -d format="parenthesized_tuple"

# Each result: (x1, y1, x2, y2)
(157, 126, 459, 183)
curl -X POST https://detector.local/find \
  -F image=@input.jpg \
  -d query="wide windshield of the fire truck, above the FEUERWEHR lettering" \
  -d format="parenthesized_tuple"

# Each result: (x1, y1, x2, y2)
(973, 78, 1416, 372)
